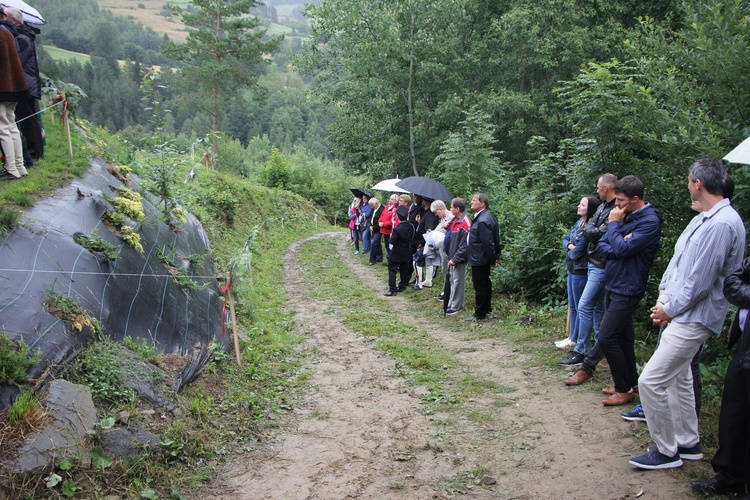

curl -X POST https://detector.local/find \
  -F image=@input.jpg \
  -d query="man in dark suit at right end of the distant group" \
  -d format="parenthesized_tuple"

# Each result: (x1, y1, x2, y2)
(466, 193, 501, 321)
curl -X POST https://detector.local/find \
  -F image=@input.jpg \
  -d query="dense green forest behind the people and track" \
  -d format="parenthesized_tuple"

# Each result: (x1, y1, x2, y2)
(34, 0, 750, 304)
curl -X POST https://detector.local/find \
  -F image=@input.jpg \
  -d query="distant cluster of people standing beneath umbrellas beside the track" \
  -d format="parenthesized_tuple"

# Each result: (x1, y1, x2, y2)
(348, 189, 501, 321)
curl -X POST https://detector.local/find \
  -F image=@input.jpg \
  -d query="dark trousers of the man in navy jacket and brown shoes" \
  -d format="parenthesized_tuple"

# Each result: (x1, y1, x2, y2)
(596, 293, 641, 392)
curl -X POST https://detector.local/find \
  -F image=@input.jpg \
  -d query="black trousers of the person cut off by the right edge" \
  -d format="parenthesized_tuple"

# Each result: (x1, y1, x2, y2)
(711, 346, 750, 485)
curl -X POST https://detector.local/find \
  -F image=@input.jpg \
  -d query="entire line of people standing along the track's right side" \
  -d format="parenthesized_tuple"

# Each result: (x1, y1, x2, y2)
(350, 159, 750, 498)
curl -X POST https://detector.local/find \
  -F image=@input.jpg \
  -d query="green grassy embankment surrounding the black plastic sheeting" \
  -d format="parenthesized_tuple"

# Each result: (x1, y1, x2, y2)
(0, 116, 330, 498)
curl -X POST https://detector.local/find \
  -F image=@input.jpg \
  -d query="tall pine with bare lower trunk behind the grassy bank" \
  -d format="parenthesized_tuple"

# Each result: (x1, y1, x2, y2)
(163, 0, 283, 155)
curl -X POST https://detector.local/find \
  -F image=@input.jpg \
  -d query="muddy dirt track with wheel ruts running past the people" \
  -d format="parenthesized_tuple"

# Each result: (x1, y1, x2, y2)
(200, 233, 710, 499)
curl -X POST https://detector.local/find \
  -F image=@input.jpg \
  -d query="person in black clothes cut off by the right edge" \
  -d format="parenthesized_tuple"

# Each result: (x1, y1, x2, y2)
(690, 258, 750, 498)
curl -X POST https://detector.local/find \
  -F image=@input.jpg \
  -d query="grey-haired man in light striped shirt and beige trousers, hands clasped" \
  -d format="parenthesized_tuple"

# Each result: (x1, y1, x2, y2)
(630, 158, 745, 469)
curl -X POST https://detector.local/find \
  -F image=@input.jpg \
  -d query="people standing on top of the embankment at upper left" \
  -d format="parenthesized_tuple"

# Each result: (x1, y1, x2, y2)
(0, 5, 44, 180)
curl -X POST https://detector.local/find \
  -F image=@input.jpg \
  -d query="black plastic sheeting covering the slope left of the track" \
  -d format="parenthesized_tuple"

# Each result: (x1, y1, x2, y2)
(0, 162, 226, 408)
